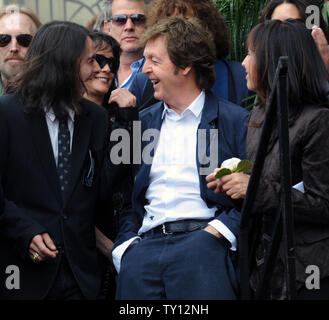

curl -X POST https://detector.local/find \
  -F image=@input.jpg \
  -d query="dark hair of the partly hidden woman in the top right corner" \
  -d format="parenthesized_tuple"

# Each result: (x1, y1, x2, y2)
(259, 0, 329, 41)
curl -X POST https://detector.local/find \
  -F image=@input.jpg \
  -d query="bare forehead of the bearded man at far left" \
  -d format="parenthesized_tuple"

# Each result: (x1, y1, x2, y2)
(0, 13, 36, 34)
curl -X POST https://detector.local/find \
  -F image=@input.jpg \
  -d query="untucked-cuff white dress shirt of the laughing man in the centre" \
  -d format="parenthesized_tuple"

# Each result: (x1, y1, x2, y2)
(112, 91, 236, 272)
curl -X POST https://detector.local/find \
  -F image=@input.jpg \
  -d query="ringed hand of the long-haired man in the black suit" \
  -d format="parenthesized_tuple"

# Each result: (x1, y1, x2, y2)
(29, 233, 58, 262)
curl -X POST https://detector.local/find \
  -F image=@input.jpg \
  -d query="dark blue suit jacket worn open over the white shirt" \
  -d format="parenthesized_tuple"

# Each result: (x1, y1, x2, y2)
(115, 92, 249, 247)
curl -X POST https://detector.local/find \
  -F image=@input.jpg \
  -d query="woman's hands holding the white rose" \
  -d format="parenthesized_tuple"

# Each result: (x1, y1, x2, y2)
(206, 168, 250, 199)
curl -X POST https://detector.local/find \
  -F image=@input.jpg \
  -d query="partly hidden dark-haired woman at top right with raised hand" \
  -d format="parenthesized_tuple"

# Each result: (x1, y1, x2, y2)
(259, 0, 329, 70)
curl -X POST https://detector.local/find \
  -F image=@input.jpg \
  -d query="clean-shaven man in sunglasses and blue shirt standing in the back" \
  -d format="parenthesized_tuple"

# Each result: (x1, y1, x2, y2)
(104, 0, 150, 89)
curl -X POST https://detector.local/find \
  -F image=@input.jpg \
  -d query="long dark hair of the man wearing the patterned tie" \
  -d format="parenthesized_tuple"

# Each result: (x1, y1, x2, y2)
(10, 21, 89, 118)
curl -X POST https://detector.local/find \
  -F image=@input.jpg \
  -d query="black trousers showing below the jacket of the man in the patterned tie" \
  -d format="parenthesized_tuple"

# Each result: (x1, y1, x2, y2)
(46, 254, 85, 300)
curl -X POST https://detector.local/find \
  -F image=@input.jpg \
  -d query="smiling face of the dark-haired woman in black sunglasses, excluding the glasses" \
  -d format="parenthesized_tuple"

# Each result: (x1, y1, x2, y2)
(85, 46, 114, 101)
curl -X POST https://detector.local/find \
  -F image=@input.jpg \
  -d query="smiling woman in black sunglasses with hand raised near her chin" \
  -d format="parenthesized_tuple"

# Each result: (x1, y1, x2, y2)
(84, 32, 136, 117)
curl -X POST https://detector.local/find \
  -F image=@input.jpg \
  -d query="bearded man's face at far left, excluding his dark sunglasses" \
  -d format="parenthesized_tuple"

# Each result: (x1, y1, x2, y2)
(0, 13, 36, 80)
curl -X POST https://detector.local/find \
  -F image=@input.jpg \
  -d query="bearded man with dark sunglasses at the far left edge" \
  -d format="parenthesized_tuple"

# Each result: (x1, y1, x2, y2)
(0, 5, 41, 93)
